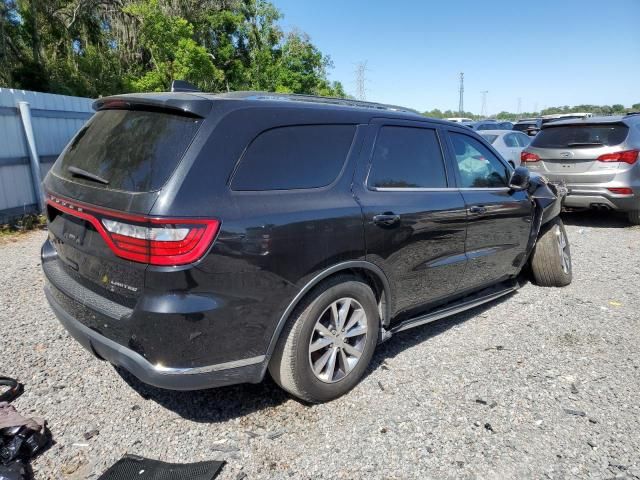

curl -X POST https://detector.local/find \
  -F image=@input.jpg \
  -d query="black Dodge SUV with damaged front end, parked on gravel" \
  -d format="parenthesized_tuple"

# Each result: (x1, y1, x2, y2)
(42, 92, 571, 402)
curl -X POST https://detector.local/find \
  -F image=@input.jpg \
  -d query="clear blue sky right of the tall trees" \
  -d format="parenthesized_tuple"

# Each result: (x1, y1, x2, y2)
(273, 0, 640, 113)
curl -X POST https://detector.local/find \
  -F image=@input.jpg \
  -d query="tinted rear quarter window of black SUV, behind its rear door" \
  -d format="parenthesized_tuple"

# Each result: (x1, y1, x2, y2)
(231, 125, 355, 190)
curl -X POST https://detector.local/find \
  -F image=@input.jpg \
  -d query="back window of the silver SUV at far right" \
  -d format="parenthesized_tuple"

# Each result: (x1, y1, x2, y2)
(531, 125, 629, 148)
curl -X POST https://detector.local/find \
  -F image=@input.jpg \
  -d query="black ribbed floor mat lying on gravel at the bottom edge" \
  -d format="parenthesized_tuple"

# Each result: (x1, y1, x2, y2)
(98, 455, 224, 480)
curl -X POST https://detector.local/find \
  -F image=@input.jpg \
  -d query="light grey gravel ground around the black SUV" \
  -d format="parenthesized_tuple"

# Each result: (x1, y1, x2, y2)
(0, 214, 640, 480)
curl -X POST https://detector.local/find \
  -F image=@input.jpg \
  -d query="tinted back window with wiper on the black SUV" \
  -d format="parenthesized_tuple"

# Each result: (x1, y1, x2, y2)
(53, 110, 202, 192)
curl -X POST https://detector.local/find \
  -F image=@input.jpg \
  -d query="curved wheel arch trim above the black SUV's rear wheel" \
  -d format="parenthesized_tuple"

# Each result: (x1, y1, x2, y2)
(263, 260, 391, 375)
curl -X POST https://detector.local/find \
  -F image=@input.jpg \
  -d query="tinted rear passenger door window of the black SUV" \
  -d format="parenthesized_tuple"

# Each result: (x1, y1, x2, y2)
(368, 127, 447, 188)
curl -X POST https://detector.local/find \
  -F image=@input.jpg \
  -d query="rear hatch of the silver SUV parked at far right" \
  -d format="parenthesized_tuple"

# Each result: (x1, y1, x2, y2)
(527, 123, 629, 183)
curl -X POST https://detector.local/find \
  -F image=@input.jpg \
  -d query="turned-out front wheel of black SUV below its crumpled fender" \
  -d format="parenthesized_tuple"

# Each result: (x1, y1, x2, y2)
(531, 218, 573, 287)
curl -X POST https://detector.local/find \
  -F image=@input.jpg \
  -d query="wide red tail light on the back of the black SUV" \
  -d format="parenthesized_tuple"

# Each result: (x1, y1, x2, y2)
(47, 195, 220, 266)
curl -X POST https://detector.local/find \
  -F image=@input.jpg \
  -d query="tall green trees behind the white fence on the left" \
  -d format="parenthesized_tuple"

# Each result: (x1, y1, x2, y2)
(0, 0, 346, 97)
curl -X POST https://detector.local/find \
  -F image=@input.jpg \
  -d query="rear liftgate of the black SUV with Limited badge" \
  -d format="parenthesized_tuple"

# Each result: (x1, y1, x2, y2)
(44, 96, 208, 307)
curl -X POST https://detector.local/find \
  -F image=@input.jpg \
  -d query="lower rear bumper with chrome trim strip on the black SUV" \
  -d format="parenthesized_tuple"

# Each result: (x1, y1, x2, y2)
(45, 285, 266, 390)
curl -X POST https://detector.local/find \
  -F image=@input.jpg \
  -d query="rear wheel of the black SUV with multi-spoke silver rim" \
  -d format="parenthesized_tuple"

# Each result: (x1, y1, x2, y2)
(269, 276, 380, 403)
